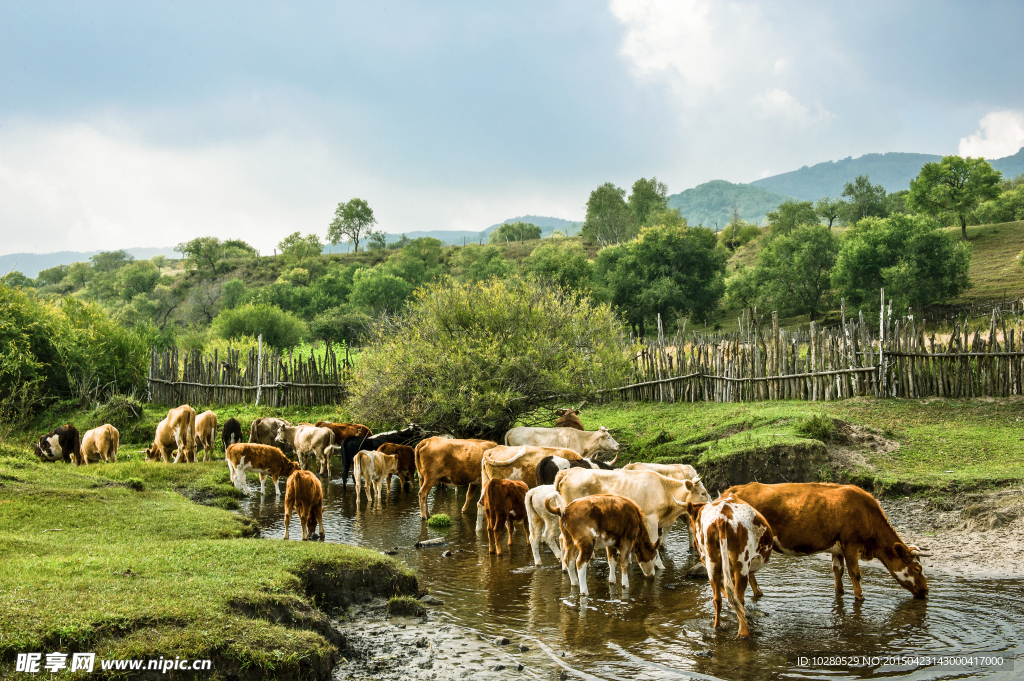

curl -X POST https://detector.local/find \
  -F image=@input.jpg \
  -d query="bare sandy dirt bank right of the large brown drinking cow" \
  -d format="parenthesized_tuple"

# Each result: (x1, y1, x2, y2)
(882, 488, 1024, 578)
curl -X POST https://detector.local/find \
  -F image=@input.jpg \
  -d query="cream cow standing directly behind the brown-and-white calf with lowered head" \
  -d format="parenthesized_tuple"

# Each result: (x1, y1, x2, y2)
(555, 468, 711, 568)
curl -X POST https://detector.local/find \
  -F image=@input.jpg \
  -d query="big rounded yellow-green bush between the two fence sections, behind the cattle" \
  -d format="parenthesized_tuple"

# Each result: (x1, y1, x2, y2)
(350, 278, 630, 437)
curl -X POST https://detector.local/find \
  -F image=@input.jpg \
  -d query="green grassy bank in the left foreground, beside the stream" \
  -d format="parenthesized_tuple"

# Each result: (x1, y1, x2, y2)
(0, 436, 417, 679)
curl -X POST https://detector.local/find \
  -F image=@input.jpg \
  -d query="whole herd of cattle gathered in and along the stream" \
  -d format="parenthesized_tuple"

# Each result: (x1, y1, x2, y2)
(36, 405, 928, 638)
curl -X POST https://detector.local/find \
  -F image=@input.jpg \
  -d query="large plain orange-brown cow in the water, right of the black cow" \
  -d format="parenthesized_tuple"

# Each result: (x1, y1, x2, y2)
(416, 436, 498, 520)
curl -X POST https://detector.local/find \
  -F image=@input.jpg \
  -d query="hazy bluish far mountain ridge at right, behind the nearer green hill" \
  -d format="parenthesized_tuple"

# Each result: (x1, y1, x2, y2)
(751, 148, 1024, 201)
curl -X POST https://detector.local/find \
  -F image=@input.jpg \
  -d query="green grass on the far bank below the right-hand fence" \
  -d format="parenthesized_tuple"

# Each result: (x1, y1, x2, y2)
(583, 398, 1024, 490)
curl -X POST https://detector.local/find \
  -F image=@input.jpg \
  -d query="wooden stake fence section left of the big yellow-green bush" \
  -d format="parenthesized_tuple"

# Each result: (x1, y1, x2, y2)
(147, 343, 352, 407)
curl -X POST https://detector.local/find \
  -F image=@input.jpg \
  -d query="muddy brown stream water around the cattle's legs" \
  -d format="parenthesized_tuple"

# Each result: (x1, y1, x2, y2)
(243, 483, 1024, 680)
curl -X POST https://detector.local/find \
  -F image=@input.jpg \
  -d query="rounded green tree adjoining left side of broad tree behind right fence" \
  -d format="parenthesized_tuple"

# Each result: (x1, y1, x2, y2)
(754, 224, 839, 322)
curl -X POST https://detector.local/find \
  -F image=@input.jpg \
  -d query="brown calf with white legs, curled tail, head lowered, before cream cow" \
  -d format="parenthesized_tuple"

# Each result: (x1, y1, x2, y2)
(544, 495, 658, 596)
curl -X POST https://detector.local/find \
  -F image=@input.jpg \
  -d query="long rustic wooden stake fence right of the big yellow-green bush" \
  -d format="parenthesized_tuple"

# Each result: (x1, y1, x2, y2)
(599, 292, 1024, 402)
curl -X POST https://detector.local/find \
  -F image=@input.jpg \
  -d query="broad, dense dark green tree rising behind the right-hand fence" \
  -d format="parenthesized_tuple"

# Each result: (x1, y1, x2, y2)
(831, 214, 971, 310)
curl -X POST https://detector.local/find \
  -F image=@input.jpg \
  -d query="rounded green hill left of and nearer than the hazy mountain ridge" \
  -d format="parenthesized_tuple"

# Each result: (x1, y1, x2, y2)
(669, 179, 790, 230)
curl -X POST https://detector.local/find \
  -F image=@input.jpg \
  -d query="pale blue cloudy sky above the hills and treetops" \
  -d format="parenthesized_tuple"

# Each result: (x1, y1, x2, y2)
(0, 0, 1024, 254)
